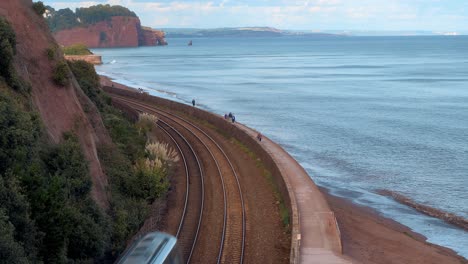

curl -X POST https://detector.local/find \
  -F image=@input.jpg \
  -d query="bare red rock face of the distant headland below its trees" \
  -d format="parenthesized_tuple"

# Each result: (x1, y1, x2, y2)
(54, 16, 167, 48)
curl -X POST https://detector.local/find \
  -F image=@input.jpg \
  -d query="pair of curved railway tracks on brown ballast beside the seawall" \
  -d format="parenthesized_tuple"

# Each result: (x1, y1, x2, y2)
(113, 95, 246, 263)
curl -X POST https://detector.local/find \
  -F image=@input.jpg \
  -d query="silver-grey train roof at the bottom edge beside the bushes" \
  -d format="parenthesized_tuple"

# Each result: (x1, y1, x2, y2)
(117, 232, 182, 264)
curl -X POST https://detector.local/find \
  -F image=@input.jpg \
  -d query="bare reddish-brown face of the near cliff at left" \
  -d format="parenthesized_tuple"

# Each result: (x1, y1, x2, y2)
(0, 0, 110, 208)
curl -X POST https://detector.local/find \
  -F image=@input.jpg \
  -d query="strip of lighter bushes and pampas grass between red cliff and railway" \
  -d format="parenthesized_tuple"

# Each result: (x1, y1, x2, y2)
(69, 61, 174, 252)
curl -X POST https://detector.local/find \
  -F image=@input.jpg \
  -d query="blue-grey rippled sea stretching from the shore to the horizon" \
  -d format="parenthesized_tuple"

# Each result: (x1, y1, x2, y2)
(94, 37, 468, 257)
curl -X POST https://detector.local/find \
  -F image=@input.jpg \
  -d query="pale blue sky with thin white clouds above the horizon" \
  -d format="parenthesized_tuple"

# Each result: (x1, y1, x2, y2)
(42, 0, 468, 32)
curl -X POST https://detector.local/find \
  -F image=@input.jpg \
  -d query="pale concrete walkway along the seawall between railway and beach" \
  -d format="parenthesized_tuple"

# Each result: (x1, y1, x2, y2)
(236, 123, 351, 263)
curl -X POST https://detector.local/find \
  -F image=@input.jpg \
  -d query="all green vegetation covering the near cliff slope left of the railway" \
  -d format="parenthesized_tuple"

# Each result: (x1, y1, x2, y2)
(0, 18, 171, 263)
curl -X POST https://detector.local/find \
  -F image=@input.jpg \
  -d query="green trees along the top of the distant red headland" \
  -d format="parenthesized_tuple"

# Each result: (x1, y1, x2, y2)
(47, 5, 136, 32)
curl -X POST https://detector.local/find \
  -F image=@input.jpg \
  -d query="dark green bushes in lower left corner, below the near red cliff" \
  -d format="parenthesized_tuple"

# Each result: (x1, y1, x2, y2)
(0, 83, 110, 263)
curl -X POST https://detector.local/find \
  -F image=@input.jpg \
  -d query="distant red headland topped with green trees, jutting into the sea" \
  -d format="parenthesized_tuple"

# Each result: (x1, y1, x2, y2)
(44, 5, 167, 48)
